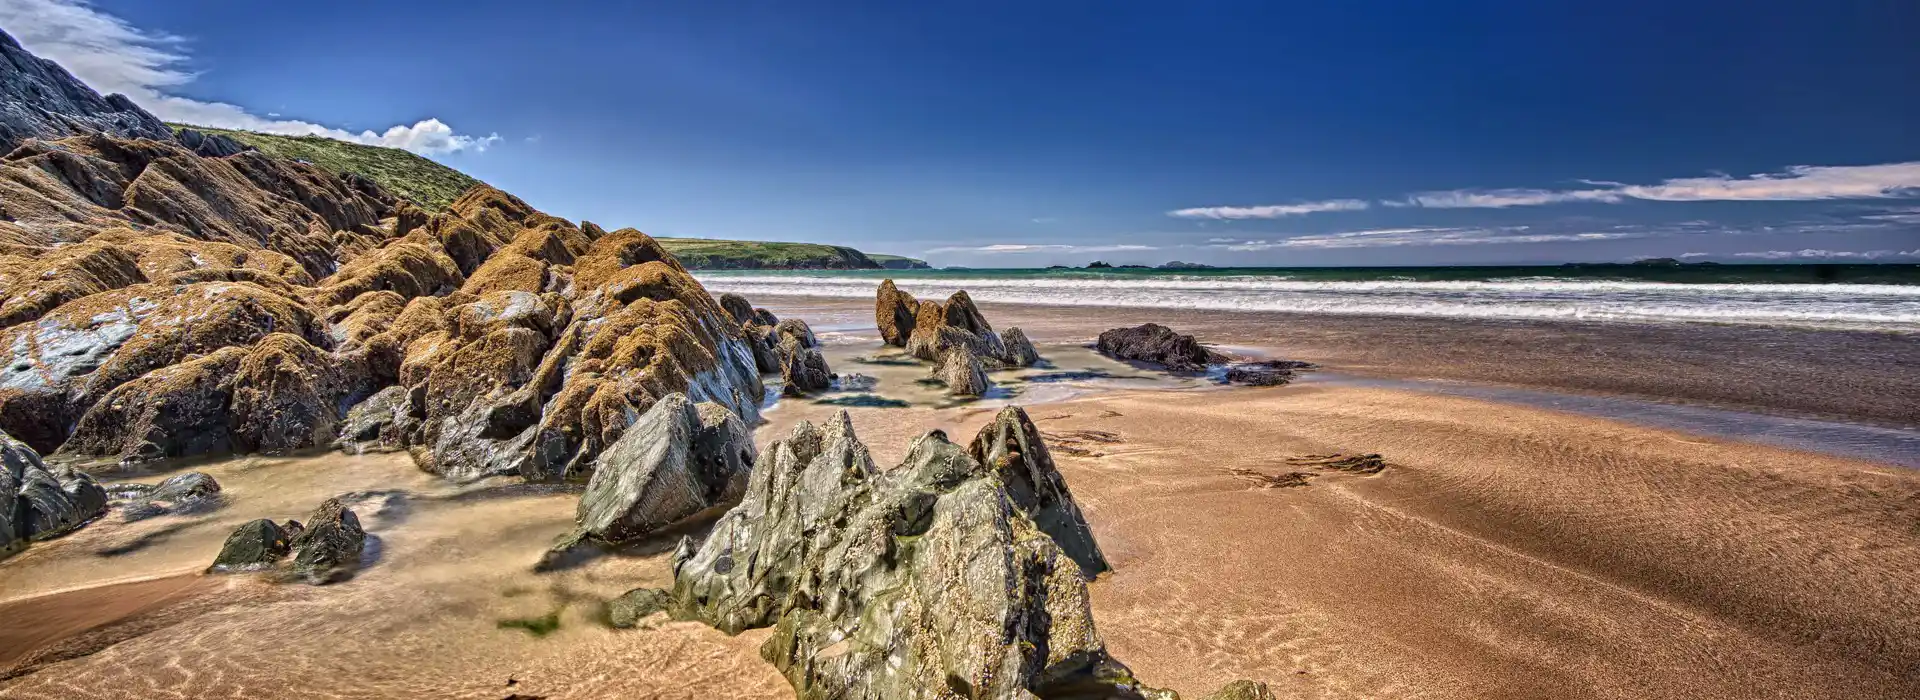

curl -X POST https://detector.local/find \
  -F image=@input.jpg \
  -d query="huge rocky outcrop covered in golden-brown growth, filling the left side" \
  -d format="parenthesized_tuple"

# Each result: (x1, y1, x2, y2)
(0, 38, 764, 479)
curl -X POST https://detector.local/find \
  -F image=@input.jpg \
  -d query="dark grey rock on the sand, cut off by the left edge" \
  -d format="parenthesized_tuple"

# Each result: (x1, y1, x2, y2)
(0, 425, 108, 558)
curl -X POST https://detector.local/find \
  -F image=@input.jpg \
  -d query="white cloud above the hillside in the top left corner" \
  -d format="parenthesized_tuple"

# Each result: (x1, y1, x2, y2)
(0, 0, 499, 155)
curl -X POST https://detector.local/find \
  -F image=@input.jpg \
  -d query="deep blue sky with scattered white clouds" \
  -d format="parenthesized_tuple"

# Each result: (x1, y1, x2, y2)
(0, 0, 1920, 267)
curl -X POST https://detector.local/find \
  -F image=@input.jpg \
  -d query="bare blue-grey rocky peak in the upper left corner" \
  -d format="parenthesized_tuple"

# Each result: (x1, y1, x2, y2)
(0, 31, 173, 152)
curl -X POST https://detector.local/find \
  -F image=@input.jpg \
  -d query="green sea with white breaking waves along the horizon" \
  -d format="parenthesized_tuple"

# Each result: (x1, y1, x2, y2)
(695, 265, 1920, 332)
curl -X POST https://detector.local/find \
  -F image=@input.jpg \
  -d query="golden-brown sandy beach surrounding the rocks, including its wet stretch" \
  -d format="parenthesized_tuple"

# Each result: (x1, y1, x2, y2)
(0, 299, 1920, 698)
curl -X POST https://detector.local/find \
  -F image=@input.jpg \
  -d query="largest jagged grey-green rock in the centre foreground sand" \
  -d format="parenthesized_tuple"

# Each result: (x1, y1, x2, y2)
(652, 412, 1150, 698)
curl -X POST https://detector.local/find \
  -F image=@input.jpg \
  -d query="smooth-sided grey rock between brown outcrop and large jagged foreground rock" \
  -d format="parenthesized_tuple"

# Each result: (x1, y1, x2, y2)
(576, 393, 755, 543)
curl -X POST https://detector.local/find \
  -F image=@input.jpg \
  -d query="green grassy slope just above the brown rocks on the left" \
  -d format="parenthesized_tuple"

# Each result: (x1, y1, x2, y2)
(169, 125, 480, 211)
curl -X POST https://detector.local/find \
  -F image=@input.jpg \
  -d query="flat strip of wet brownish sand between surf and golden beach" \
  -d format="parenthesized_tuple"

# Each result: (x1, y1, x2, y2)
(753, 289, 1920, 428)
